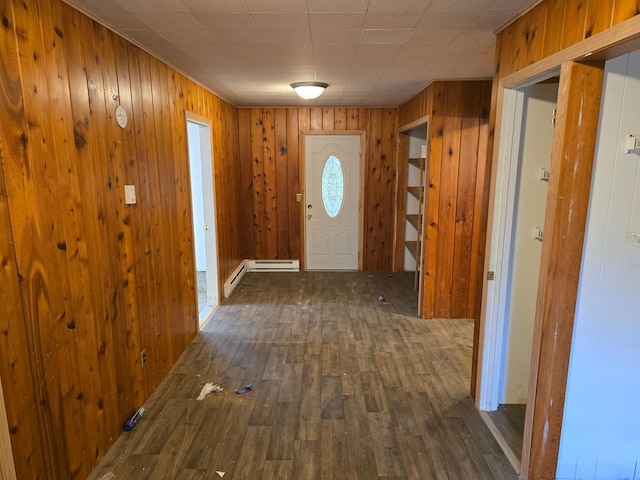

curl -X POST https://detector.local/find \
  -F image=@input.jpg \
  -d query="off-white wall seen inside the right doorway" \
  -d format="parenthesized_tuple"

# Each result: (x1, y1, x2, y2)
(499, 84, 558, 404)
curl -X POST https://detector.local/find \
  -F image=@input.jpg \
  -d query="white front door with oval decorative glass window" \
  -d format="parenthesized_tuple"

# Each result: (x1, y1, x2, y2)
(305, 135, 360, 270)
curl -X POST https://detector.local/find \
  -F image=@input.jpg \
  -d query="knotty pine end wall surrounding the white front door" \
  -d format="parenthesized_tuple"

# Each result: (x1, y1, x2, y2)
(238, 107, 398, 270)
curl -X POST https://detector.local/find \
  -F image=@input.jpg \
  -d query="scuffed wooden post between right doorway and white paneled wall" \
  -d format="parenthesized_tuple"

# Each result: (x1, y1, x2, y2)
(523, 62, 604, 478)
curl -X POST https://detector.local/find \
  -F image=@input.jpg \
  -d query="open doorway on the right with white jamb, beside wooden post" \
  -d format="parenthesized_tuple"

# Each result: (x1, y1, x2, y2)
(478, 77, 558, 471)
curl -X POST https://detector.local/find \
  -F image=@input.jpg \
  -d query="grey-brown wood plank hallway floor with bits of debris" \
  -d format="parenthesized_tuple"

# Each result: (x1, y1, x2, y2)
(90, 272, 517, 480)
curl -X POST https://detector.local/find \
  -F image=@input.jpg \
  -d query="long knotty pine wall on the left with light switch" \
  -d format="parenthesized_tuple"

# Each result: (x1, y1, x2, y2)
(0, 0, 243, 479)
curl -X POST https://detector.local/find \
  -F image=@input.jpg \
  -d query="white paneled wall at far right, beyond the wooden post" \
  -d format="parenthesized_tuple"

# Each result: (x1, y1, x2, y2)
(557, 53, 640, 480)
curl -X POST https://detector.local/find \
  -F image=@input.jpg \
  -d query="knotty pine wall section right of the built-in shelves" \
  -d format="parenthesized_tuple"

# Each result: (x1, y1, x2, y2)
(396, 80, 491, 319)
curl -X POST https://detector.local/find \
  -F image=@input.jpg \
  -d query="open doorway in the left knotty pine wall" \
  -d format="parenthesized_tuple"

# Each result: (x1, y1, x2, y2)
(187, 113, 220, 326)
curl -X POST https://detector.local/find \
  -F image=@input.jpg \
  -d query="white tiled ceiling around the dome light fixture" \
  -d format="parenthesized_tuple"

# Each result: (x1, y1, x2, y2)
(65, 0, 536, 107)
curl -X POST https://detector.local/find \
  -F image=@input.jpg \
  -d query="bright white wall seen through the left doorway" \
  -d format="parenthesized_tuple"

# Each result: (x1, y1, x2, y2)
(187, 122, 207, 272)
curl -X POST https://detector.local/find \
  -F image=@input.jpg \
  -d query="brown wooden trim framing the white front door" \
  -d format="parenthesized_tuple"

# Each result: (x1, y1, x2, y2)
(298, 130, 367, 272)
